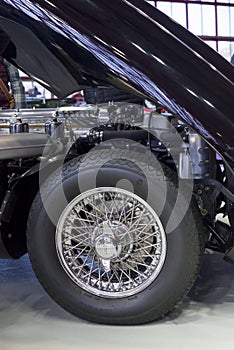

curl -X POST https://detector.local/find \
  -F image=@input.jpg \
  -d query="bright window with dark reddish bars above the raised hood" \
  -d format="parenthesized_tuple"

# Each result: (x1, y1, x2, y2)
(146, 0, 234, 60)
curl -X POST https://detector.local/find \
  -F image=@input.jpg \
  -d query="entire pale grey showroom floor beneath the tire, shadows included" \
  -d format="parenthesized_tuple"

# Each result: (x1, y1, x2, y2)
(0, 250, 234, 350)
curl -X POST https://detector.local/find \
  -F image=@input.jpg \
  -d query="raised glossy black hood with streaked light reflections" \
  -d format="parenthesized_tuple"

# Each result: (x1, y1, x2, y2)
(0, 0, 234, 169)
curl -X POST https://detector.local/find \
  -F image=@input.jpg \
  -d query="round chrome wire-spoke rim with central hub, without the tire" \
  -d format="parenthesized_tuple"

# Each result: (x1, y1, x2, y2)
(55, 187, 167, 298)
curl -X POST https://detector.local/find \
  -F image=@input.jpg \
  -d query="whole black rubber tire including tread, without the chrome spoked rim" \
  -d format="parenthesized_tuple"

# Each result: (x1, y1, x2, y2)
(27, 150, 204, 324)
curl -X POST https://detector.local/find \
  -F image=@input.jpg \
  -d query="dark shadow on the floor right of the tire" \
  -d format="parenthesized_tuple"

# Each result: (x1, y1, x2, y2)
(160, 251, 234, 324)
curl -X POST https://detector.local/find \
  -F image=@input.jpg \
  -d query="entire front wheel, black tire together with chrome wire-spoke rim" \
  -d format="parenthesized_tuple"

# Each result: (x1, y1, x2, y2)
(28, 151, 204, 324)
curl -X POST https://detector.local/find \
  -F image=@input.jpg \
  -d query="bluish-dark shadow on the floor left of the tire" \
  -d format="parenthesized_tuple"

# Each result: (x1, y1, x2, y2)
(0, 255, 77, 327)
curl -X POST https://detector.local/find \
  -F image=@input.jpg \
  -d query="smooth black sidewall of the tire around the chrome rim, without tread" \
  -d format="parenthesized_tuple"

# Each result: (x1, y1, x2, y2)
(29, 159, 199, 324)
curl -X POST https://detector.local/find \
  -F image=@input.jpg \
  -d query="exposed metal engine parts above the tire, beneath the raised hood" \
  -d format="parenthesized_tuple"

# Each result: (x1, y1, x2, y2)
(0, 103, 233, 262)
